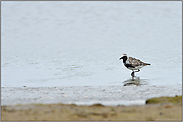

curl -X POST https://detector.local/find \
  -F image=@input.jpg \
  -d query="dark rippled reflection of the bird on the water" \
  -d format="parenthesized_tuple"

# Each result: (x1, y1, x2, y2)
(123, 77, 147, 86)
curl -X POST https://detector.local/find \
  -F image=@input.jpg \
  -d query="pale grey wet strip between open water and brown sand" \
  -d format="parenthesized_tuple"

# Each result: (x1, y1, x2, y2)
(1, 84, 182, 106)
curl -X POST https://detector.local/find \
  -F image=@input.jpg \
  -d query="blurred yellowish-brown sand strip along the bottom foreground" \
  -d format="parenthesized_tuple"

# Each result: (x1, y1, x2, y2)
(1, 97, 182, 121)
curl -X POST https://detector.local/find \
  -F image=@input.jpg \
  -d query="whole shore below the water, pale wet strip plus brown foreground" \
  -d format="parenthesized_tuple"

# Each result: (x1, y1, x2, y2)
(1, 85, 182, 121)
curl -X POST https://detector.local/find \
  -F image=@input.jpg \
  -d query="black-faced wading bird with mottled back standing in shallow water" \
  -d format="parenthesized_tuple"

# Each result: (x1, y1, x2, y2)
(119, 54, 151, 77)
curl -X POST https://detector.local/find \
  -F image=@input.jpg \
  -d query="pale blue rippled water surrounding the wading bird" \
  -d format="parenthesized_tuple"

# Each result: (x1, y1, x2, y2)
(1, 1, 182, 87)
